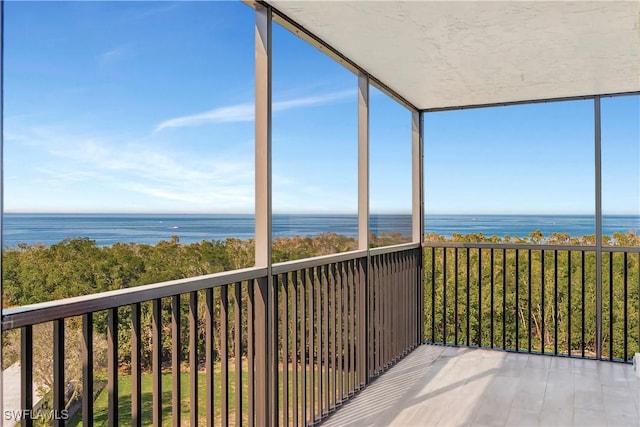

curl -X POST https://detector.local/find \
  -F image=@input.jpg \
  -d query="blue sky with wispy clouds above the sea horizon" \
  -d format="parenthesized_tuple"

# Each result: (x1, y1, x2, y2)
(4, 2, 640, 214)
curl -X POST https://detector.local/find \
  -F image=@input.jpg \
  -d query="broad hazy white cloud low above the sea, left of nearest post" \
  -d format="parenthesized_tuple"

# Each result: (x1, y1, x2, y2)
(7, 128, 254, 212)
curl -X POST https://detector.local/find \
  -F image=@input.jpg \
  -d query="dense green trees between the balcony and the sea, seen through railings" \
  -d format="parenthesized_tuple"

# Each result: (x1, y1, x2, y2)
(2, 231, 640, 414)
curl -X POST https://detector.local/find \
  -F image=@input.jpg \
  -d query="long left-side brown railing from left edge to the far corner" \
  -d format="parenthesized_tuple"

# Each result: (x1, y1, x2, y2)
(2, 244, 422, 426)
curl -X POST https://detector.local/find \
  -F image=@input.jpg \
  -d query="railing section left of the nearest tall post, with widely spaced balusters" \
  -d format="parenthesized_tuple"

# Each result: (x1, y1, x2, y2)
(3, 268, 266, 426)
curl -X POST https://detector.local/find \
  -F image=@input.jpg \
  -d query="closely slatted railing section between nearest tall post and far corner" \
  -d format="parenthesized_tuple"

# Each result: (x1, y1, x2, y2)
(273, 244, 421, 426)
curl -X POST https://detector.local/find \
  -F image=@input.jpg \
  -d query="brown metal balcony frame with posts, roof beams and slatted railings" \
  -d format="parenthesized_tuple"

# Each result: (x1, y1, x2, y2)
(0, 2, 640, 426)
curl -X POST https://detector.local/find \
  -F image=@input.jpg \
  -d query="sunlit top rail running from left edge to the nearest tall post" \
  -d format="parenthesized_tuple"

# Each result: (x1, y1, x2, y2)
(2, 267, 267, 331)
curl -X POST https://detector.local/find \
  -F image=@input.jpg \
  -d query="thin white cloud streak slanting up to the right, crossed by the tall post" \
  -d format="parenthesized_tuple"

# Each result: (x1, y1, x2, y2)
(155, 90, 355, 132)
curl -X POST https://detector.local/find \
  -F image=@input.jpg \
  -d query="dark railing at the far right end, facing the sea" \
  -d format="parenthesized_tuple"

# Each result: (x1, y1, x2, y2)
(424, 242, 640, 362)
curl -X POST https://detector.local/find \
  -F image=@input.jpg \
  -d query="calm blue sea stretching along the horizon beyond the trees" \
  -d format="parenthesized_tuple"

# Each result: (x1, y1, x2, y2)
(2, 214, 640, 248)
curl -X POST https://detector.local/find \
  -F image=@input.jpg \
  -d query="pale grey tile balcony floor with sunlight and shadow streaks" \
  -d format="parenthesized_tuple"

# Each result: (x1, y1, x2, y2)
(322, 345, 640, 427)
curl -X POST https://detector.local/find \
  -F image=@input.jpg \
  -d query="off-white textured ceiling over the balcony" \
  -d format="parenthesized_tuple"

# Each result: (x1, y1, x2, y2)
(269, 0, 640, 109)
